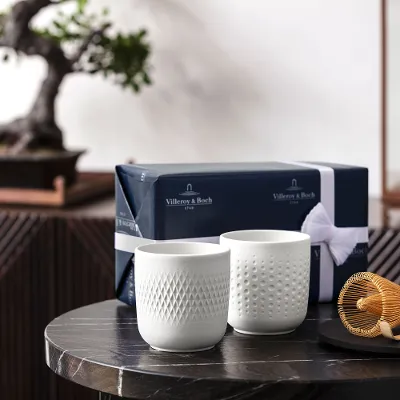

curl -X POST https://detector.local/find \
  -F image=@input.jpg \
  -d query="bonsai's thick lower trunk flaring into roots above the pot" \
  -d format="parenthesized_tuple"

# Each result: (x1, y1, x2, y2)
(0, 64, 67, 154)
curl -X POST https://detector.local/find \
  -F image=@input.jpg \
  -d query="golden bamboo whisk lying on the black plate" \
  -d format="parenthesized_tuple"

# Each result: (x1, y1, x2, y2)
(338, 272, 400, 337)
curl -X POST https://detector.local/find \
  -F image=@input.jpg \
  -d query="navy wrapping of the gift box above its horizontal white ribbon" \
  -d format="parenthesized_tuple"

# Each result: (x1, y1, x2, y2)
(116, 162, 368, 240)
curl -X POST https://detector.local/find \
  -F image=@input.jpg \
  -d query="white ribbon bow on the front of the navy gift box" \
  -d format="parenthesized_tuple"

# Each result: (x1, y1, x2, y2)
(301, 203, 360, 265)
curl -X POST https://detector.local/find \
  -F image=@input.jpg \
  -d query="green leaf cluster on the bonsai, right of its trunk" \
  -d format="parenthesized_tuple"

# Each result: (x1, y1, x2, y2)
(0, 0, 152, 93)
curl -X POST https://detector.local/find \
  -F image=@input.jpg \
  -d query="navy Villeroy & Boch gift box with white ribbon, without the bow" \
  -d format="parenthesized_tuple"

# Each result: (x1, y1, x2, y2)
(115, 162, 368, 305)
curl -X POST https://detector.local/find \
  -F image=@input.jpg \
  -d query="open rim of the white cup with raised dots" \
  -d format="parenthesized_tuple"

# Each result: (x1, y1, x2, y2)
(220, 229, 311, 244)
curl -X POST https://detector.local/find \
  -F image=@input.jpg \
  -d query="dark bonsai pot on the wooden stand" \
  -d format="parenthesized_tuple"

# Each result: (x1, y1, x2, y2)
(0, 151, 85, 189)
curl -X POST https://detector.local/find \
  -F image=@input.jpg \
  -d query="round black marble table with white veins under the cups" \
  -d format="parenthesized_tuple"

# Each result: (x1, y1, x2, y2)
(45, 300, 400, 400)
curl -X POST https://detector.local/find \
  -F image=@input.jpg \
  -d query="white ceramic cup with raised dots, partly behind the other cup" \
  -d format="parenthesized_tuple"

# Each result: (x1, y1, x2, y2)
(220, 230, 311, 335)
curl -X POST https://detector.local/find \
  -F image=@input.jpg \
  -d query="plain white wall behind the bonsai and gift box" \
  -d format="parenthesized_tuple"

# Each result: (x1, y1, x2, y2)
(0, 0, 380, 194)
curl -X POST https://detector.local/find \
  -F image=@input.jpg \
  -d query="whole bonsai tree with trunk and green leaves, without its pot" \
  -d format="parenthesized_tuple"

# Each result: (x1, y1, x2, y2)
(0, 0, 151, 154)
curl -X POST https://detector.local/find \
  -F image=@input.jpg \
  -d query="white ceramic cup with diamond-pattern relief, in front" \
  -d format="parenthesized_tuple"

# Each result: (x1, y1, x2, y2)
(135, 242, 230, 352)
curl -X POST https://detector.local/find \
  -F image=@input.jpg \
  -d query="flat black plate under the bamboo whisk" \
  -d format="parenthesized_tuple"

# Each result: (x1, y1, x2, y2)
(319, 319, 400, 355)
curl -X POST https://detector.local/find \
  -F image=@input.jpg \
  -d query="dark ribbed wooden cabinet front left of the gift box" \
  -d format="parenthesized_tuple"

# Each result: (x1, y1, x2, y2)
(0, 199, 114, 400)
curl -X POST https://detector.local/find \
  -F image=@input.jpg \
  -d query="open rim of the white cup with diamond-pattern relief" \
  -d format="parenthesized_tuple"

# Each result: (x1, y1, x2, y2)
(135, 240, 230, 258)
